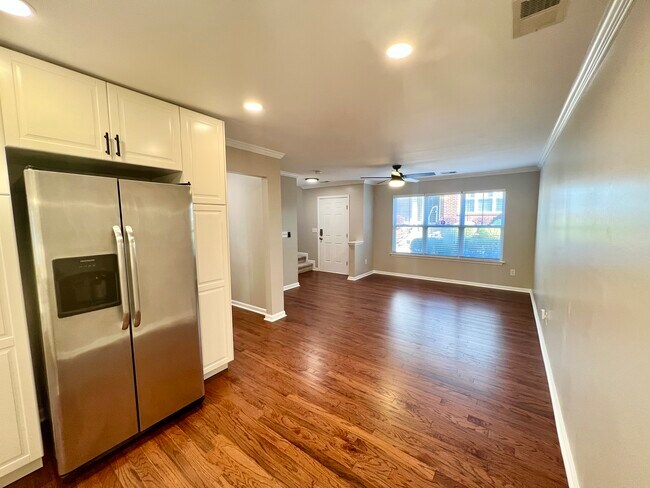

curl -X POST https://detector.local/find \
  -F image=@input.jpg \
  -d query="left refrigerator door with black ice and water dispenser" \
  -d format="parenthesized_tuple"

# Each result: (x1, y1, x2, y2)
(25, 169, 138, 474)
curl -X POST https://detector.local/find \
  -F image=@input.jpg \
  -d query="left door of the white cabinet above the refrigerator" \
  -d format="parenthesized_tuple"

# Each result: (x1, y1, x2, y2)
(0, 49, 111, 159)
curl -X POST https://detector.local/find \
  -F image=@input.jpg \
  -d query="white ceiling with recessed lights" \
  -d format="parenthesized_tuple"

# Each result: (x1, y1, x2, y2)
(0, 0, 608, 184)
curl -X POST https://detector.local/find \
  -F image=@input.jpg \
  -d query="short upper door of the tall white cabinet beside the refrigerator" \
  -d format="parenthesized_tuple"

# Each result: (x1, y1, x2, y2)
(181, 108, 226, 205)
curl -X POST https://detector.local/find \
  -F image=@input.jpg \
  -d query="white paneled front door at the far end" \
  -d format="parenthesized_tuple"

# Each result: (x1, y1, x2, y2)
(318, 195, 348, 274)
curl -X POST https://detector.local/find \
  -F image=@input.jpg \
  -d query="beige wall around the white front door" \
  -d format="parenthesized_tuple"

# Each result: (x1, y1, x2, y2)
(298, 185, 370, 276)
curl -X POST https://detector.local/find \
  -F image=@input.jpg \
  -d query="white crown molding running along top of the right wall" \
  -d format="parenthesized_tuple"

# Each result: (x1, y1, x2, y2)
(539, 0, 634, 168)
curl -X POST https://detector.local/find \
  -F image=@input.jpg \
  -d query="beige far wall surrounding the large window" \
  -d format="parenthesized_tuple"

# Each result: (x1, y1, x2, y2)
(373, 172, 539, 288)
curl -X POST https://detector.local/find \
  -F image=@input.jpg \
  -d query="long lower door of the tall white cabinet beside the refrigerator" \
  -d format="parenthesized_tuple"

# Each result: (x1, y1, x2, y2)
(194, 204, 234, 378)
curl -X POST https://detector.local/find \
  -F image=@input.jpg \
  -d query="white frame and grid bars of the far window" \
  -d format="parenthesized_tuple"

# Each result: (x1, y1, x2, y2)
(391, 189, 507, 264)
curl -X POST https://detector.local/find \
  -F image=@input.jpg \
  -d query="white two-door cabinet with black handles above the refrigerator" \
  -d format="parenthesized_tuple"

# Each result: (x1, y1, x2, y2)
(0, 48, 187, 173)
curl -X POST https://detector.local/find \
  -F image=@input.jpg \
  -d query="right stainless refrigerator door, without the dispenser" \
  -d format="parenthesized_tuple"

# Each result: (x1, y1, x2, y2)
(119, 180, 204, 430)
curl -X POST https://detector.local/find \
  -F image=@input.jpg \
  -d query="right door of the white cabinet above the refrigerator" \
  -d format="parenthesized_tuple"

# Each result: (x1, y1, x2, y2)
(108, 84, 183, 171)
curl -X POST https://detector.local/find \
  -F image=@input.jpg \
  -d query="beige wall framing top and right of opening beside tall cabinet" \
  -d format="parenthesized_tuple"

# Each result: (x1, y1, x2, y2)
(226, 147, 284, 315)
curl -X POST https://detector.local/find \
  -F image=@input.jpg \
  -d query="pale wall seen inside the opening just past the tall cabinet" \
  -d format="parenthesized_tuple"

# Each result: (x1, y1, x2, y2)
(228, 173, 267, 310)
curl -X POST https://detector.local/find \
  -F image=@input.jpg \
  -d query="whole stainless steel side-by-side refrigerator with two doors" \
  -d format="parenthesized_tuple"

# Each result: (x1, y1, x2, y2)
(24, 169, 204, 475)
